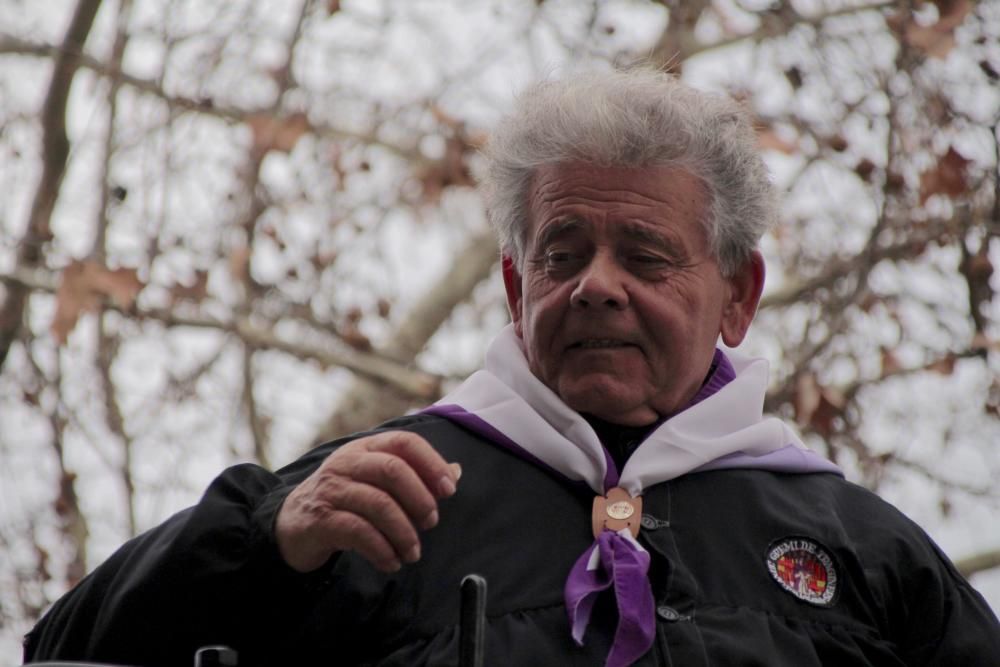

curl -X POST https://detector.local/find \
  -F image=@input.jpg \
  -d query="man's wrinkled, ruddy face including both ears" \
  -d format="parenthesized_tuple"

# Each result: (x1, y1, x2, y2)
(504, 163, 764, 426)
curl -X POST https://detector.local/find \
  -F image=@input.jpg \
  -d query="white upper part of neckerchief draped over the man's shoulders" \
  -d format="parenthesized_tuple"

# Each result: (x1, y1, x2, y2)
(435, 325, 840, 496)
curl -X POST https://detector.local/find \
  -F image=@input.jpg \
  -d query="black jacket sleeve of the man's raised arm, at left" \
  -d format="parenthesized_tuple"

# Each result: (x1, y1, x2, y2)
(24, 460, 329, 666)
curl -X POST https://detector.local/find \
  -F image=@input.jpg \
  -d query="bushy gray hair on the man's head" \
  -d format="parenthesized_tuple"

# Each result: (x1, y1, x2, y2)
(479, 68, 777, 276)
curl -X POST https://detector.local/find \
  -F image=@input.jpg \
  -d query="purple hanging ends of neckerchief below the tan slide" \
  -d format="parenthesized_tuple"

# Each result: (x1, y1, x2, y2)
(565, 530, 656, 667)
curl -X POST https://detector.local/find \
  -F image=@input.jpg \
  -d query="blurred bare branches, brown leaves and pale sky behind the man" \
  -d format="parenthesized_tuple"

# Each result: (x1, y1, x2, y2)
(0, 0, 1000, 665)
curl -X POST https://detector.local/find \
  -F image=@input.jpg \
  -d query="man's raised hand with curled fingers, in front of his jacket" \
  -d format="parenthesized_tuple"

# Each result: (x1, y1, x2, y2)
(275, 432, 461, 572)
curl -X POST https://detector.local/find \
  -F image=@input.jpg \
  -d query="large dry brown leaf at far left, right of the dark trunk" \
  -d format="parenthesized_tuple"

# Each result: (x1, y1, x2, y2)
(50, 260, 144, 345)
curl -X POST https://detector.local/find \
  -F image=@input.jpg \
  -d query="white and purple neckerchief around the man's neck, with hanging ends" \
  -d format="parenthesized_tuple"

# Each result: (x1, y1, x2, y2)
(423, 325, 840, 667)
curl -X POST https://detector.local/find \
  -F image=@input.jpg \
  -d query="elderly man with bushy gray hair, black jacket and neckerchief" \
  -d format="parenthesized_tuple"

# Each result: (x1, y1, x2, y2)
(26, 71, 1000, 667)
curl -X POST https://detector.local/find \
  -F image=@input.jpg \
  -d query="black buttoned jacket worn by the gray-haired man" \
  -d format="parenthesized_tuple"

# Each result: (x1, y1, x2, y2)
(25, 416, 1000, 667)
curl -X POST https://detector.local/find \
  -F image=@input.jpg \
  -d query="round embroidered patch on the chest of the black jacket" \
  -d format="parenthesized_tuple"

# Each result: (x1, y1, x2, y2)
(767, 536, 837, 607)
